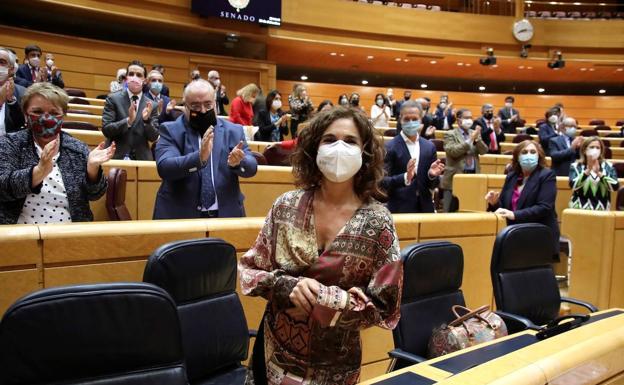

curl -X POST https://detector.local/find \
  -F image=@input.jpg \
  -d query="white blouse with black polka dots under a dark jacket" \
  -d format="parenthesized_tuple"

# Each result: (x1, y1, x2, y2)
(17, 143, 71, 225)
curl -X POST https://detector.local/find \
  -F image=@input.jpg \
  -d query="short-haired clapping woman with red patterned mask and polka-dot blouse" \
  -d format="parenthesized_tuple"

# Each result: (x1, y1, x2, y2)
(0, 83, 115, 224)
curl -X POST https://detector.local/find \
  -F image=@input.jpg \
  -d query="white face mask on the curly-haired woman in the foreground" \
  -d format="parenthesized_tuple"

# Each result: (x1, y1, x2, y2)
(316, 140, 362, 183)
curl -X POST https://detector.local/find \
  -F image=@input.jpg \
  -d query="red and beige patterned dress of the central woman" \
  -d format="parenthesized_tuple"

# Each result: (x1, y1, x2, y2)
(239, 190, 403, 385)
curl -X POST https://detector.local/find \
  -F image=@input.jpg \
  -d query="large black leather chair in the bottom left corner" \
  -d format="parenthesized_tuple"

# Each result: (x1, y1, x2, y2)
(0, 283, 187, 385)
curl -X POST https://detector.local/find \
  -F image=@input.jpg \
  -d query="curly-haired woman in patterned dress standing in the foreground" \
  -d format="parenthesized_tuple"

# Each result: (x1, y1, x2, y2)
(239, 107, 403, 385)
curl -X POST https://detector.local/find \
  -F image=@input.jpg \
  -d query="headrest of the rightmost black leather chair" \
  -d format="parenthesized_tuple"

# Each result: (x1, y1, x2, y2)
(491, 223, 556, 272)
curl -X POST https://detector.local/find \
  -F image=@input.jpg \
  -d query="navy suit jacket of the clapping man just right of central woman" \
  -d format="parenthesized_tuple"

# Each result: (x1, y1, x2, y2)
(382, 134, 440, 213)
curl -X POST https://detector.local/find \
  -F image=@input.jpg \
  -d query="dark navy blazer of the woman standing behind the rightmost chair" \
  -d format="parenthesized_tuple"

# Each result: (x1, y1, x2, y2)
(489, 166, 559, 256)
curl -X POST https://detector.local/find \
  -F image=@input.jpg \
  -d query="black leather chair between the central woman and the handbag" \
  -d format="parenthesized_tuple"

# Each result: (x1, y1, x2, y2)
(388, 241, 465, 370)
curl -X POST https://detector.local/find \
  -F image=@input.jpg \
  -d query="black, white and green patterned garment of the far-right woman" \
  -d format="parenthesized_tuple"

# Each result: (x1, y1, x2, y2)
(569, 161, 619, 211)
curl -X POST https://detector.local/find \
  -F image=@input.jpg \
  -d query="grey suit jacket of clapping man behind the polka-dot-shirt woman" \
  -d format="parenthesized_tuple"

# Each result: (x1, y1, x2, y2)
(102, 90, 159, 160)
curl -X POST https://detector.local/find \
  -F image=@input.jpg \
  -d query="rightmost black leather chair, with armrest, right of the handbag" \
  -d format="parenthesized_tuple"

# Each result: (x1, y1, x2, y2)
(490, 223, 598, 333)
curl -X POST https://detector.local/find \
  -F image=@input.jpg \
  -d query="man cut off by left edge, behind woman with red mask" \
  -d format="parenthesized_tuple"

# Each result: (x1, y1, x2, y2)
(0, 47, 26, 136)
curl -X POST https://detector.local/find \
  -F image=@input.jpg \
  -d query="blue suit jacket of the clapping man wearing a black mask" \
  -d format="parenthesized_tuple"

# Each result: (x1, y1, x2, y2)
(154, 115, 258, 219)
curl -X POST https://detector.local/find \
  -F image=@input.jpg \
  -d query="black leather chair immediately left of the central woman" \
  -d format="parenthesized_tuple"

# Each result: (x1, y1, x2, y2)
(143, 238, 254, 385)
